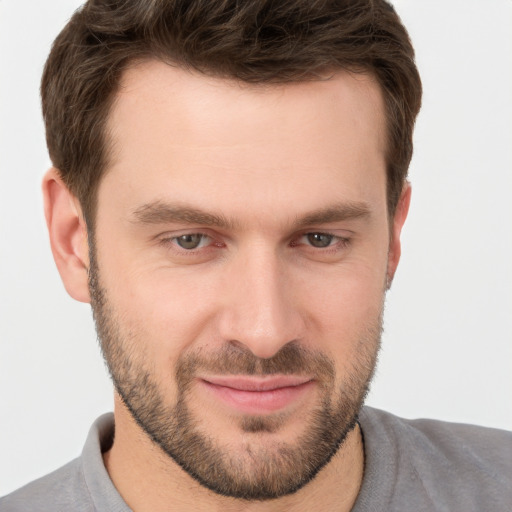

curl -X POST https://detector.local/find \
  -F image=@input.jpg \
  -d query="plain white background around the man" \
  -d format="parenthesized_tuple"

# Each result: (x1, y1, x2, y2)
(0, 0, 512, 495)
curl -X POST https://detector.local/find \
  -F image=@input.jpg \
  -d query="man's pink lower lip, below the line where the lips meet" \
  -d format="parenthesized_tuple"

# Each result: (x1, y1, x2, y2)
(200, 380, 314, 414)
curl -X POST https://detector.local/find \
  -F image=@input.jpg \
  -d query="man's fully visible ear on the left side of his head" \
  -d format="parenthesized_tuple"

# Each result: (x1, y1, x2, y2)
(43, 168, 90, 302)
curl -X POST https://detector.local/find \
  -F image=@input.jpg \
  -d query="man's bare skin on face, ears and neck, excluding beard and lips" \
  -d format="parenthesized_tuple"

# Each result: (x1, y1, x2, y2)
(43, 61, 410, 512)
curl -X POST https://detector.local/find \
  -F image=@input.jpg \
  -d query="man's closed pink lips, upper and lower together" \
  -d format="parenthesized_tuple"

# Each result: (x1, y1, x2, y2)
(199, 375, 314, 414)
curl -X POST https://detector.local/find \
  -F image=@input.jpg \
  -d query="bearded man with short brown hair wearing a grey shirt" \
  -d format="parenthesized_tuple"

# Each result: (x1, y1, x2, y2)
(0, 1, 511, 511)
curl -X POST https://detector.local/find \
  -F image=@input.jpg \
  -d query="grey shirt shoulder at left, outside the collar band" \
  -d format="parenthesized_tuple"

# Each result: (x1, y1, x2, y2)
(0, 458, 94, 512)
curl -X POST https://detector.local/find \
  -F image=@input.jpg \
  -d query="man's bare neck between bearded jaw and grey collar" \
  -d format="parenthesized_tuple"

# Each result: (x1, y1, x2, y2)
(103, 397, 364, 512)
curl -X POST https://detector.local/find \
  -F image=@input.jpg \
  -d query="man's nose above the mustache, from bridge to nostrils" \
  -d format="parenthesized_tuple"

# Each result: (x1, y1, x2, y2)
(218, 245, 304, 359)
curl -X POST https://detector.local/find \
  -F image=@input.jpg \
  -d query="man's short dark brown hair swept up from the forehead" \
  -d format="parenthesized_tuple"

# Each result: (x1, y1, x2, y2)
(41, 0, 422, 229)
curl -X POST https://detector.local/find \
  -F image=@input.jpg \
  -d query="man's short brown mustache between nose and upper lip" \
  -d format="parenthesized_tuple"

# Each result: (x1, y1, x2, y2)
(176, 342, 336, 383)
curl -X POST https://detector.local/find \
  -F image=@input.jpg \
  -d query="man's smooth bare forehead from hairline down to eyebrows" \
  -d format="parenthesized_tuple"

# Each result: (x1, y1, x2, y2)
(100, 61, 385, 222)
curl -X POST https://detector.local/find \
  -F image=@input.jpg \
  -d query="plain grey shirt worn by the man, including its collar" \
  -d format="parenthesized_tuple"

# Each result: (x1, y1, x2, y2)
(0, 407, 512, 512)
